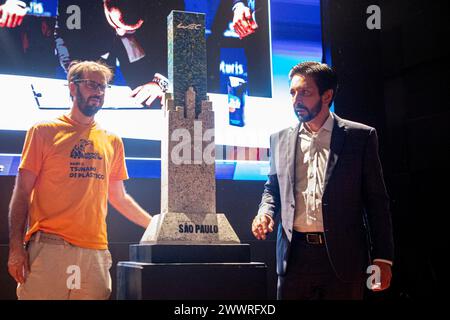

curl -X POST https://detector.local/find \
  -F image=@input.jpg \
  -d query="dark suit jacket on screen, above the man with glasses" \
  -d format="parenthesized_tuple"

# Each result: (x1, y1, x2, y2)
(56, 0, 184, 89)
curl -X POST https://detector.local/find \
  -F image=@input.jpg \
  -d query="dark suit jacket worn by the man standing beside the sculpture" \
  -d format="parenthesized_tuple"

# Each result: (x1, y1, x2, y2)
(258, 115, 394, 282)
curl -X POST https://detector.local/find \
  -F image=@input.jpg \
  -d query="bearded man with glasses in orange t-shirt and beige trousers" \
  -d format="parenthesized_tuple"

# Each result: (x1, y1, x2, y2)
(8, 61, 151, 299)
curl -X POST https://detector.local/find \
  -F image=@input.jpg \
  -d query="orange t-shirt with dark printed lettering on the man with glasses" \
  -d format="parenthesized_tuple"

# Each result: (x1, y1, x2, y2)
(19, 115, 128, 249)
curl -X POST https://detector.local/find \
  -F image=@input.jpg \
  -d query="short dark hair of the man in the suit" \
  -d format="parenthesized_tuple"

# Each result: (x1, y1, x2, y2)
(289, 61, 338, 105)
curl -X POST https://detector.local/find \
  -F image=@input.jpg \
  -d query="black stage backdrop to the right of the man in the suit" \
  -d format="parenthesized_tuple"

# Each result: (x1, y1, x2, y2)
(321, 0, 450, 299)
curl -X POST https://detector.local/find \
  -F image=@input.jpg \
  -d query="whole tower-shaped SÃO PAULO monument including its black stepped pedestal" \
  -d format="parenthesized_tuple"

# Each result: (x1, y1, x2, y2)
(117, 11, 267, 299)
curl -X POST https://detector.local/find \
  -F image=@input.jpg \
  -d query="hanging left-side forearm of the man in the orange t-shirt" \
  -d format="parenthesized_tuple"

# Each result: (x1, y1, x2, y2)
(8, 187, 29, 247)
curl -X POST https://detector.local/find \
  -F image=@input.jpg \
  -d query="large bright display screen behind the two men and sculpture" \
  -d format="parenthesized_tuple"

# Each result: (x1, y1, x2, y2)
(0, 0, 322, 180)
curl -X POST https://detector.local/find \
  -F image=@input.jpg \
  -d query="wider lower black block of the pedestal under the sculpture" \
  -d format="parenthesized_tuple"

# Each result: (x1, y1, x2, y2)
(117, 261, 267, 300)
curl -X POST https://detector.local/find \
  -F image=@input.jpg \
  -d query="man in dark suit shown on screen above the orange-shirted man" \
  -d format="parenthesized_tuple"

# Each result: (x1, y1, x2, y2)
(55, 0, 184, 107)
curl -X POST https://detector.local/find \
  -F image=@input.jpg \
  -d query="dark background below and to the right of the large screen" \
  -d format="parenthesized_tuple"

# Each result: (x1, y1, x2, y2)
(0, 0, 450, 300)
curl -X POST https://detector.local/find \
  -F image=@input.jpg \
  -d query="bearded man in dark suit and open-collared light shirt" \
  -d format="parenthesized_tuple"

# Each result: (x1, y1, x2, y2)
(252, 62, 394, 299)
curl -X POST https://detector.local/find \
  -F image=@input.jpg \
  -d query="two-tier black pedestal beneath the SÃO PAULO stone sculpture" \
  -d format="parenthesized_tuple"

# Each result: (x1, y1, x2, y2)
(117, 244, 267, 300)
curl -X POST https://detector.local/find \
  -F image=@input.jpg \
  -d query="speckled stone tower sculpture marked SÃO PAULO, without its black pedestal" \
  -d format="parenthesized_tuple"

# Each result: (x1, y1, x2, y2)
(141, 11, 240, 244)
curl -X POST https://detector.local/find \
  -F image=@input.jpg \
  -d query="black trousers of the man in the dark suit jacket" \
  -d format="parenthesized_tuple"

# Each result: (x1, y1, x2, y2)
(277, 232, 364, 300)
